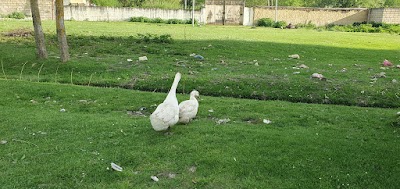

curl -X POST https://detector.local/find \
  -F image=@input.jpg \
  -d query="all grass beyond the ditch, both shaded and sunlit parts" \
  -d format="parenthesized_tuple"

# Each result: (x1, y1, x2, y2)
(0, 21, 400, 108)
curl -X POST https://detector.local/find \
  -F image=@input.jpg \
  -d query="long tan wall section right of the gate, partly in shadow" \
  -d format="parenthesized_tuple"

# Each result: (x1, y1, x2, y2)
(254, 7, 368, 26)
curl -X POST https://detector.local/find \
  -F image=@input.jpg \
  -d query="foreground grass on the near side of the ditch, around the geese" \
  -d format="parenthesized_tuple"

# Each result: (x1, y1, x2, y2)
(0, 78, 400, 188)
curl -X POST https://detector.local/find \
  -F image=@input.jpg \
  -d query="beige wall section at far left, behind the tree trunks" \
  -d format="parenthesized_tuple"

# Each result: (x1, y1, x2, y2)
(0, 0, 55, 20)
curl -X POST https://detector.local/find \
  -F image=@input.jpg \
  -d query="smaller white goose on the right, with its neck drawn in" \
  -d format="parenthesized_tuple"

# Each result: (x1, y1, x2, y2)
(179, 90, 200, 124)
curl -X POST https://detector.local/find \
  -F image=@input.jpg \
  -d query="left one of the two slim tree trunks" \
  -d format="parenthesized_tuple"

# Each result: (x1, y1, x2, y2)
(30, 0, 47, 59)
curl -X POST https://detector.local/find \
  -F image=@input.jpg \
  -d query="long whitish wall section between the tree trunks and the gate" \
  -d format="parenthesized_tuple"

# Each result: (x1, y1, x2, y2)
(64, 6, 202, 21)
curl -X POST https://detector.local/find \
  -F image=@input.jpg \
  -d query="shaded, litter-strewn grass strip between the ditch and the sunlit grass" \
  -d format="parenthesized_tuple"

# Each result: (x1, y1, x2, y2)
(0, 29, 400, 107)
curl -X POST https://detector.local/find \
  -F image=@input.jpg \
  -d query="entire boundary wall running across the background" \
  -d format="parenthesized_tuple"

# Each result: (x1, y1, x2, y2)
(0, 0, 400, 26)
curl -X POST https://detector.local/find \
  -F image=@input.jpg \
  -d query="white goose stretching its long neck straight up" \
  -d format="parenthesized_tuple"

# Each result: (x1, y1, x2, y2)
(150, 72, 181, 131)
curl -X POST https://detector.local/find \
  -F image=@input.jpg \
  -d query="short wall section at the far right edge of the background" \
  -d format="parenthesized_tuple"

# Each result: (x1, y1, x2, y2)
(369, 8, 400, 24)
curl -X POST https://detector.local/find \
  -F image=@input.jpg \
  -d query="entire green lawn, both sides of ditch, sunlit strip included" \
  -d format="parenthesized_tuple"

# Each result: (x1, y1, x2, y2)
(0, 21, 400, 189)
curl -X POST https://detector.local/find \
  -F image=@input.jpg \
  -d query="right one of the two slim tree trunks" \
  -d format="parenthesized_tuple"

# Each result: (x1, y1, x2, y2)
(56, 0, 69, 62)
